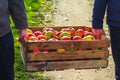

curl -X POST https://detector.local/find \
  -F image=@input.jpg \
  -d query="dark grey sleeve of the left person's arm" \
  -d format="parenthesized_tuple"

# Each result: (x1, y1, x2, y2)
(8, 0, 28, 29)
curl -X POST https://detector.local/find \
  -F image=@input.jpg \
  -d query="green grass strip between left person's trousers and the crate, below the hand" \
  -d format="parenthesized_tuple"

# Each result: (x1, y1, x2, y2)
(12, 27, 50, 80)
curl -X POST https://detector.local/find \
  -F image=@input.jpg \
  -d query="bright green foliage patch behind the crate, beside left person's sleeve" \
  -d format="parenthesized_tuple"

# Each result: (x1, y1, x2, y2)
(25, 0, 55, 26)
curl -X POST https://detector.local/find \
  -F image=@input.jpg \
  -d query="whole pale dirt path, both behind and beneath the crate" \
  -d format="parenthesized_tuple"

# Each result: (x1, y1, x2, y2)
(44, 0, 114, 80)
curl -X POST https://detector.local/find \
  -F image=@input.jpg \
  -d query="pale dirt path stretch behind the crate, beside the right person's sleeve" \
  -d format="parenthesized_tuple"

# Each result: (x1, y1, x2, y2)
(55, 0, 91, 25)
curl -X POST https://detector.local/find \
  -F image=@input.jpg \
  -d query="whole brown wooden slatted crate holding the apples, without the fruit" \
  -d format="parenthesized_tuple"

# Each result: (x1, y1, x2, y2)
(20, 26, 110, 71)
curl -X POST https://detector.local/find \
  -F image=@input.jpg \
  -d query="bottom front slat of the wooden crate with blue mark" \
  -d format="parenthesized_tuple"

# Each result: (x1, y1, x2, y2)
(26, 60, 108, 71)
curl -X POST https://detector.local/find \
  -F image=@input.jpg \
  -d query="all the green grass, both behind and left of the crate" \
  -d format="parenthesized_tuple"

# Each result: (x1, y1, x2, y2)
(10, 0, 55, 80)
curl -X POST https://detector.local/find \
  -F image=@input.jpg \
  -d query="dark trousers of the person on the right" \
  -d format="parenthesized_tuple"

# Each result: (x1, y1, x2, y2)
(110, 26, 120, 80)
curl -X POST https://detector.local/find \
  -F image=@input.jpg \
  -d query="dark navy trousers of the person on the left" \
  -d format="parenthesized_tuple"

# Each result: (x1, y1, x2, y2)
(0, 32, 14, 80)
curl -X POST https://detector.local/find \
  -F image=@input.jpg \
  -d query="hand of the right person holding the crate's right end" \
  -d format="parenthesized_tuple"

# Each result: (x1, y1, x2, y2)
(92, 29, 106, 40)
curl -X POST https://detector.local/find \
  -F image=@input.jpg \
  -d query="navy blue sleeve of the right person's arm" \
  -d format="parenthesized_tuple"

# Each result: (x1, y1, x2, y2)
(92, 0, 108, 29)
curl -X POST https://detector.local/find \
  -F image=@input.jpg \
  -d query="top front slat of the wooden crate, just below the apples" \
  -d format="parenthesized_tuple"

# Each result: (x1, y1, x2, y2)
(26, 40, 109, 50)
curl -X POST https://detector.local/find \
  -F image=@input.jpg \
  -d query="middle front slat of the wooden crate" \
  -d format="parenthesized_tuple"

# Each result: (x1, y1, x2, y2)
(27, 50, 109, 61)
